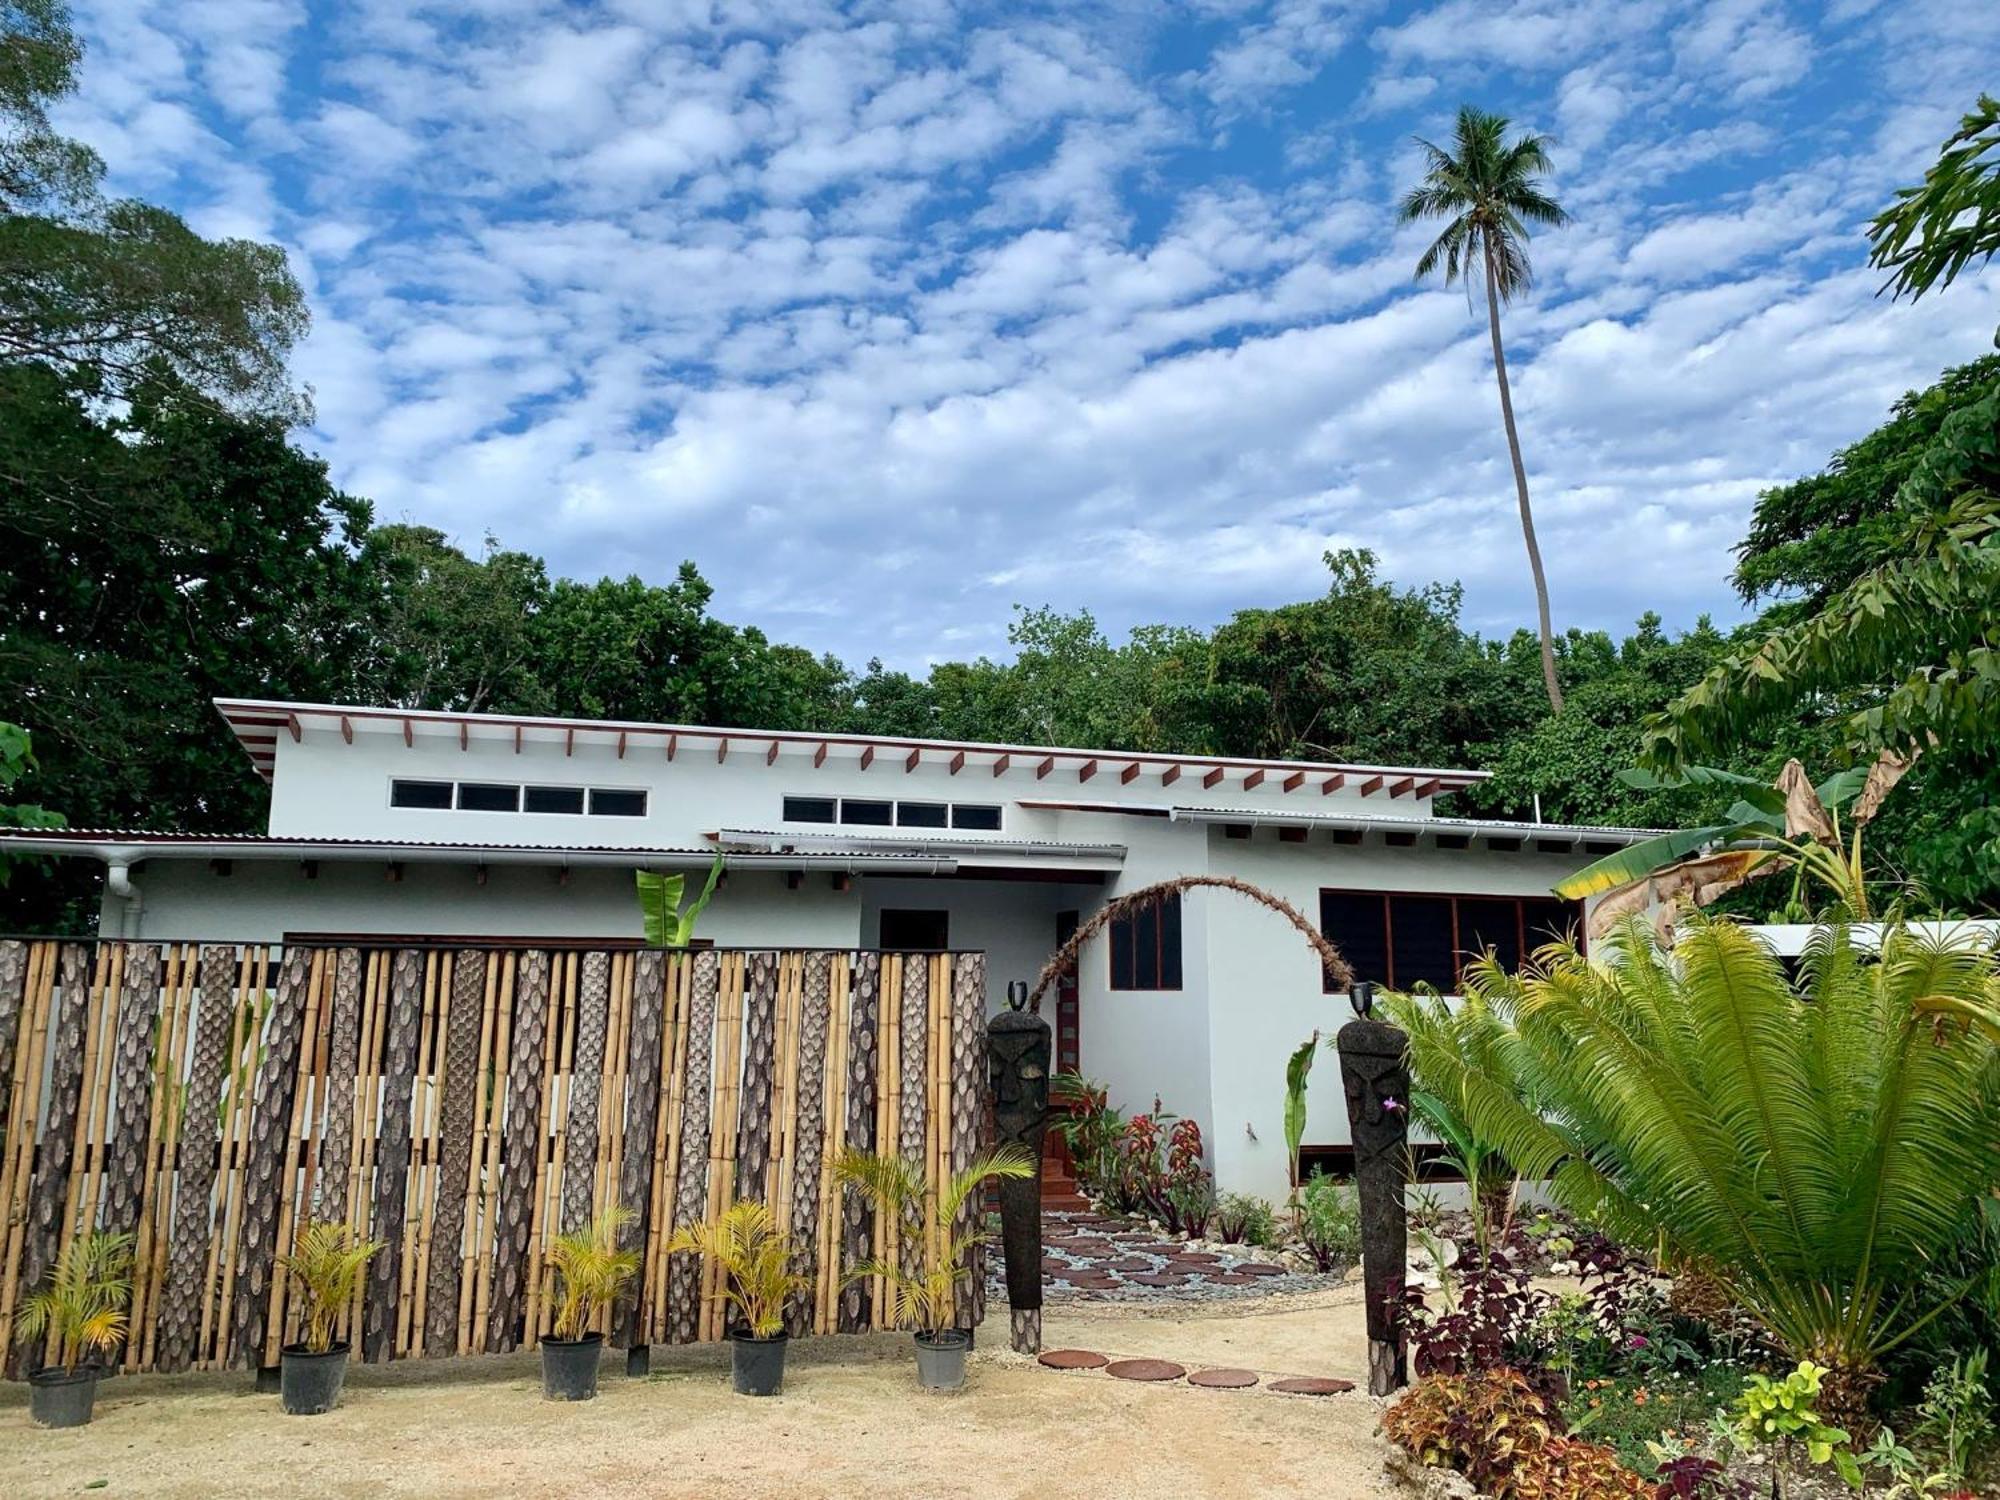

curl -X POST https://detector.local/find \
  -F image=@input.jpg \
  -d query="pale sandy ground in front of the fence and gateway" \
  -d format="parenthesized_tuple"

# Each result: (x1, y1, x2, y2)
(0, 1288, 1394, 1500)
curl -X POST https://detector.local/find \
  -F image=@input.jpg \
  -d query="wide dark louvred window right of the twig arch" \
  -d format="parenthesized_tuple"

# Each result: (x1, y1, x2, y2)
(1320, 890, 1580, 994)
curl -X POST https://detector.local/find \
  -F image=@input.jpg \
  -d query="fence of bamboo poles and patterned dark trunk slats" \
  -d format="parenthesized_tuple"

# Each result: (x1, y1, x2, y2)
(0, 938, 986, 1374)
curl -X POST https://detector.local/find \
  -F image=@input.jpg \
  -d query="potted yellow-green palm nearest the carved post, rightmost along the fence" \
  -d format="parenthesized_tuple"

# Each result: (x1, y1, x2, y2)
(836, 1146, 1036, 1390)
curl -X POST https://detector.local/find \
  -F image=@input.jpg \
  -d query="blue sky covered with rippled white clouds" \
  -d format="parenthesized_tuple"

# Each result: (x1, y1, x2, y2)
(62, 0, 2000, 666)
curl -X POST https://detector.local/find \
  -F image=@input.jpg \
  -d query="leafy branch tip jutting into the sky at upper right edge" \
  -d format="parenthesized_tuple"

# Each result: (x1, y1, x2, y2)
(1868, 94, 2000, 300)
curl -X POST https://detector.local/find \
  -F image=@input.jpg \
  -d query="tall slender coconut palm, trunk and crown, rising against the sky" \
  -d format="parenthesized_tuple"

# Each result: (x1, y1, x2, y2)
(1400, 104, 1570, 714)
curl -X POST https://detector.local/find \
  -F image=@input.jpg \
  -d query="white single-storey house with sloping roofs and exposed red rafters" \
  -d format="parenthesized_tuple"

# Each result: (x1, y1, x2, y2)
(0, 700, 1646, 1196)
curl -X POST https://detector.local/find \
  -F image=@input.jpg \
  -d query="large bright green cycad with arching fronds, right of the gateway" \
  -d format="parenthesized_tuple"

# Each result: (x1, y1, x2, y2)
(1390, 914, 2000, 1414)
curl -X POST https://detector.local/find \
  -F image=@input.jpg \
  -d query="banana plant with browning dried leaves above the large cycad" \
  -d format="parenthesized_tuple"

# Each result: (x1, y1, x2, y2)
(1556, 750, 1916, 938)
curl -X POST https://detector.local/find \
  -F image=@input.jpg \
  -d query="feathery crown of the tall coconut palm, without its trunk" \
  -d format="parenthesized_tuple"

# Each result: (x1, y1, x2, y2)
(1400, 104, 1570, 302)
